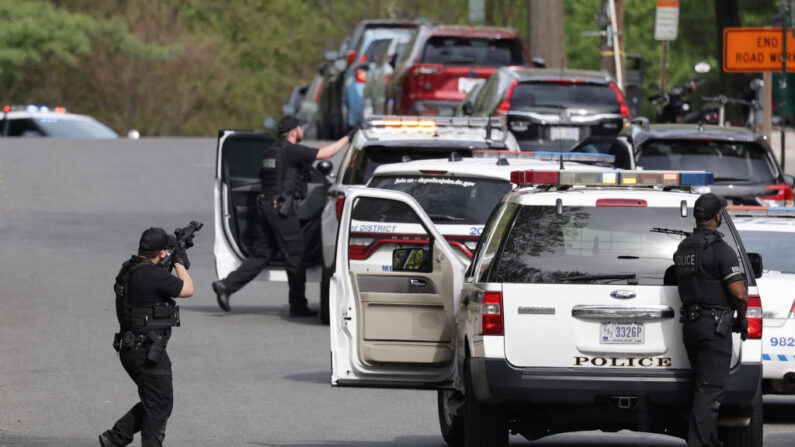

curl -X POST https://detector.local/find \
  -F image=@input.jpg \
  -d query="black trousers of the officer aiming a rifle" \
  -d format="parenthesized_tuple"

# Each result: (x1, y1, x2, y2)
(105, 348, 174, 447)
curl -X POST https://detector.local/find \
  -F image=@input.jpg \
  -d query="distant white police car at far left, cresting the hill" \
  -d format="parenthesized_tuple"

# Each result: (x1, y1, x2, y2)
(0, 105, 119, 138)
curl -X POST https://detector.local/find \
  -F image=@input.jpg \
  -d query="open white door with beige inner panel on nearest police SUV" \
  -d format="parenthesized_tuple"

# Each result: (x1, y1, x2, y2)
(330, 187, 465, 388)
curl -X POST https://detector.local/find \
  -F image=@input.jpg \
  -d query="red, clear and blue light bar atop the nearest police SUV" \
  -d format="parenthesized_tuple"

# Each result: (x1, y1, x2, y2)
(511, 170, 713, 186)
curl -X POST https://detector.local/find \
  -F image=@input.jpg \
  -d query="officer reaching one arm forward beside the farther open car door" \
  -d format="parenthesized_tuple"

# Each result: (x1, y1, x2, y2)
(212, 115, 356, 317)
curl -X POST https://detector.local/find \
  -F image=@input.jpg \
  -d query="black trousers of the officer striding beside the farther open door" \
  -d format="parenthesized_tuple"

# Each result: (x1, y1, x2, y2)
(223, 203, 306, 308)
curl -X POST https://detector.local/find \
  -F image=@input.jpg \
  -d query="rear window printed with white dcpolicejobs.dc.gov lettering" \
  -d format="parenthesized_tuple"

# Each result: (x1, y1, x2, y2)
(369, 175, 511, 225)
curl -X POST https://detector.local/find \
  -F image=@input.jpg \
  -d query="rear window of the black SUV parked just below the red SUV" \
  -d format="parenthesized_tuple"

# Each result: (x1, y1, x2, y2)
(511, 82, 620, 113)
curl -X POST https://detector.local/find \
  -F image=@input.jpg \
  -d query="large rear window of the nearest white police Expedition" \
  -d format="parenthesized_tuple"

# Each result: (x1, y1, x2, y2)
(496, 206, 737, 286)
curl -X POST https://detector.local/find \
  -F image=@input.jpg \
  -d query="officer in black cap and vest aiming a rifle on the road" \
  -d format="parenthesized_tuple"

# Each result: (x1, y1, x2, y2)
(99, 228, 193, 447)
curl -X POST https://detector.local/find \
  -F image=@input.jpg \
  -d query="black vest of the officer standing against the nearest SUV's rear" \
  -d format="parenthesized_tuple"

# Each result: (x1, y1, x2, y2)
(674, 231, 729, 309)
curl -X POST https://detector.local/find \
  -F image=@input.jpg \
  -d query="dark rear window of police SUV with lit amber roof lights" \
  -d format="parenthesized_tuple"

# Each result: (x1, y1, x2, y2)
(342, 146, 472, 185)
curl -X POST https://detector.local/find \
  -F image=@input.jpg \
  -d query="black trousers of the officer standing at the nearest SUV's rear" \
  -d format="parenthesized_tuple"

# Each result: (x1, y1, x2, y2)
(682, 311, 732, 447)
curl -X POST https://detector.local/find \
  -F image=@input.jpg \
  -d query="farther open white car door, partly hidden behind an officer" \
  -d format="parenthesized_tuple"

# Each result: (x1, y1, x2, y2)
(213, 130, 325, 281)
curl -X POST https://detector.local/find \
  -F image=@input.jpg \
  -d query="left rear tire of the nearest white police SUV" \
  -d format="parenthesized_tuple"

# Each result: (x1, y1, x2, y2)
(463, 359, 508, 447)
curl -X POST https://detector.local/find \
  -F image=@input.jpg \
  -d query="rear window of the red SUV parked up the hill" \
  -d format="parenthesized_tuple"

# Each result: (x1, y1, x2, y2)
(421, 36, 527, 67)
